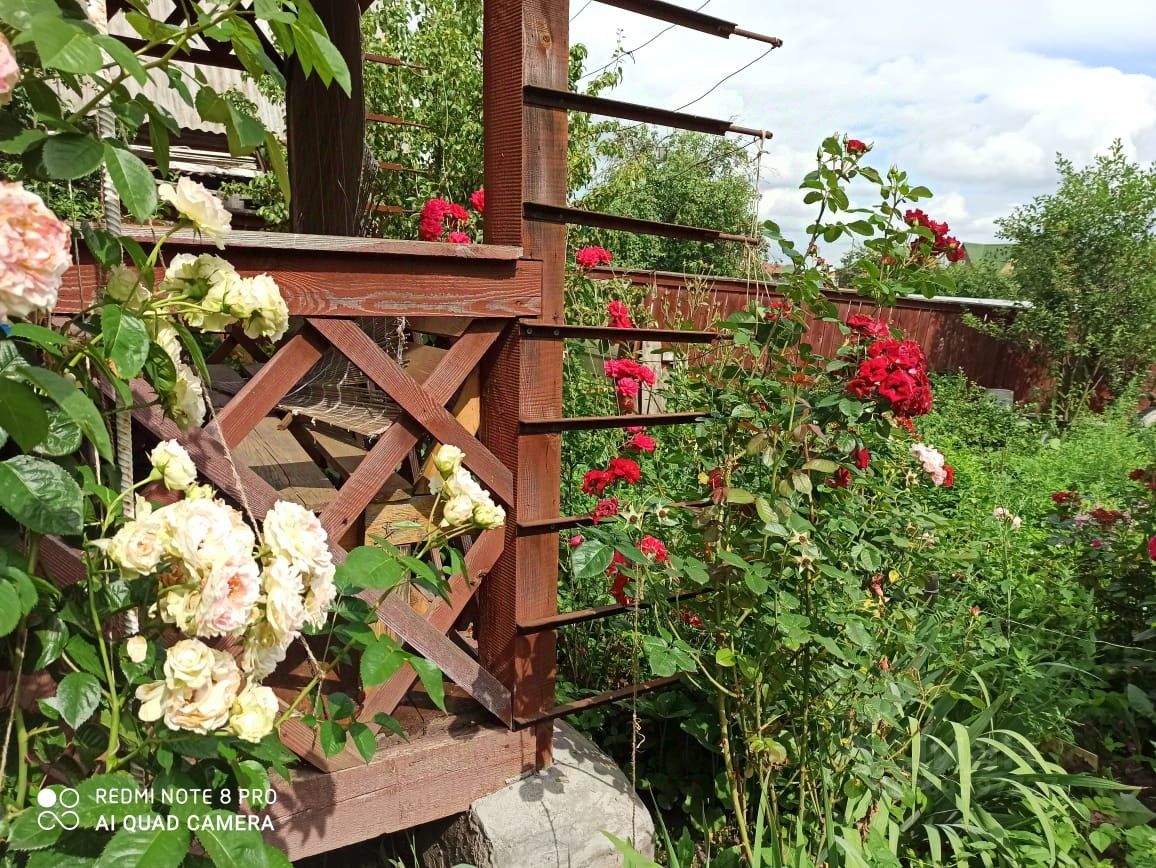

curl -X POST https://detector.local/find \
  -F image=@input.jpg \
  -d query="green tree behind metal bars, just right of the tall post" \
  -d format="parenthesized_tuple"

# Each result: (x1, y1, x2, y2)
(572, 124, 763, 275)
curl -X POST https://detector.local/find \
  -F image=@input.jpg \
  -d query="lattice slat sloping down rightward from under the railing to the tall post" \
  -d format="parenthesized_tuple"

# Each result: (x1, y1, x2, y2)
(310, 319, 514, 507)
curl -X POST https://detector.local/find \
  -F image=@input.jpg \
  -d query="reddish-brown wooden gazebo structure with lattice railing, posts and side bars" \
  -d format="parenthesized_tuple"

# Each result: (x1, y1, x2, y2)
(45, 0, 777, 859)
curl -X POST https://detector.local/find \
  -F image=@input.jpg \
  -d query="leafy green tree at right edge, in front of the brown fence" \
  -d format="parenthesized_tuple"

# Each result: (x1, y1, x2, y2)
(980, 141, 1156, 423)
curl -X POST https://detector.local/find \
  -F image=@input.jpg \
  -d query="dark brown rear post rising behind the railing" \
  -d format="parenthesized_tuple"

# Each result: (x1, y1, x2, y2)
(286, 0, 365, 236)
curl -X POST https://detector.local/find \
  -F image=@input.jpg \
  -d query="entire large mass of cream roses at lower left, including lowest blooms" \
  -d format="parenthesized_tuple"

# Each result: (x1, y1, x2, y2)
(101, 442, 336, 741)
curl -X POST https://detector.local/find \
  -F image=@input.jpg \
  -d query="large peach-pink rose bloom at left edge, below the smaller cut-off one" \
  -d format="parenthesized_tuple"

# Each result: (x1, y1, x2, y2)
(0, 181, 71, 321)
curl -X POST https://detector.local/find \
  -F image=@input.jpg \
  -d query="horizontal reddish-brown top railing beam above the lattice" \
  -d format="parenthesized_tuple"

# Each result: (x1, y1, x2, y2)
(57, 250, 541, 318)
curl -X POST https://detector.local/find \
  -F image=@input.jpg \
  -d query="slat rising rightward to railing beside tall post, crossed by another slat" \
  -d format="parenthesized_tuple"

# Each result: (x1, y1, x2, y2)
(321, 319, 506, 539)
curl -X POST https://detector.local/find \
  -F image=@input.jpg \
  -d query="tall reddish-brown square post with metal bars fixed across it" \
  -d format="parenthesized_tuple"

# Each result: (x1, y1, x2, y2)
(479, 0, 570, 766)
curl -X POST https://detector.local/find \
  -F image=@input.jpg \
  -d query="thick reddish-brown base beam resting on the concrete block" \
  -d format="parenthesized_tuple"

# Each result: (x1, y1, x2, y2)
(262, 722, 534, 861)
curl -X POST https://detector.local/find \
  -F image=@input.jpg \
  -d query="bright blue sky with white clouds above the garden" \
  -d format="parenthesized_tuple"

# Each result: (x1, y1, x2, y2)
(570, 0, 1156, 254)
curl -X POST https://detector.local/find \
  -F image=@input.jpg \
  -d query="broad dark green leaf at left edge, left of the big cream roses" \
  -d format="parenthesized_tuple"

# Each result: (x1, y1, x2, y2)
(0, 455, 84, 536)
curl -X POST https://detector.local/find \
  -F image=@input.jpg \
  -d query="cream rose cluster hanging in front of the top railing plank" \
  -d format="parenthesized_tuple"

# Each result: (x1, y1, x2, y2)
(160, 253, 289, 341)
